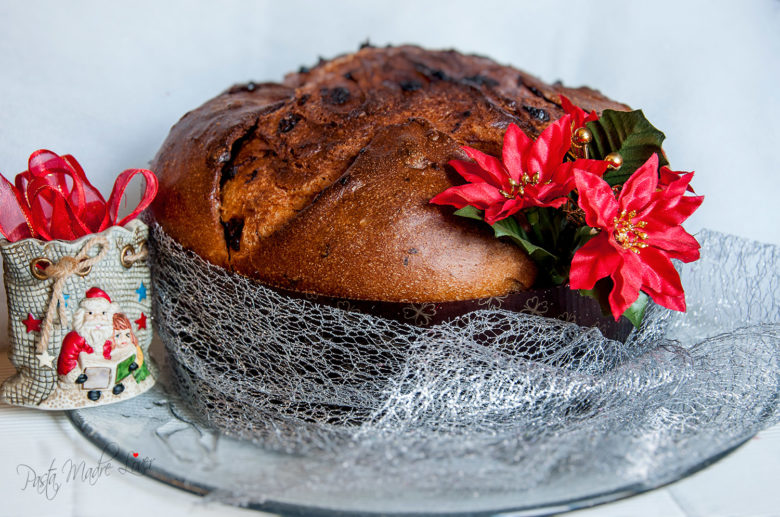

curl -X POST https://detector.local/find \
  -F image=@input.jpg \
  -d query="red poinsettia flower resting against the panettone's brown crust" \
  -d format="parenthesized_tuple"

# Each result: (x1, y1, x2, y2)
(431, 115, 607, 224)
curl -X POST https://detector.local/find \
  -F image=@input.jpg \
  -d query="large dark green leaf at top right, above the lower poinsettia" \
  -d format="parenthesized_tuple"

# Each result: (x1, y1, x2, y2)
(586, 110, 669, 186)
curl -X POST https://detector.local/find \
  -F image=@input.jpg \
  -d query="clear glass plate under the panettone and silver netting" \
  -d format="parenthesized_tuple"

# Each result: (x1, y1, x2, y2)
(68, 383, 744, 516)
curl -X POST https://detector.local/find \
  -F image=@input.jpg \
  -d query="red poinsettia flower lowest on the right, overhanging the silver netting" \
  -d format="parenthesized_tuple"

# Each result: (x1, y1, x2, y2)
(569, 155, 704, 320)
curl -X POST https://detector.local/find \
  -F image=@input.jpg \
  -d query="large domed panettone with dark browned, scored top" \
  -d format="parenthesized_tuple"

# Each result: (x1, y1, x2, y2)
(152, 46, 626, 302)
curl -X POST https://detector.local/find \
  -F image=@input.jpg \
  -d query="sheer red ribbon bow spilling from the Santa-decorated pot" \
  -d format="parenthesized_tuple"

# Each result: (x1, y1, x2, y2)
(0, 149, 157, 242)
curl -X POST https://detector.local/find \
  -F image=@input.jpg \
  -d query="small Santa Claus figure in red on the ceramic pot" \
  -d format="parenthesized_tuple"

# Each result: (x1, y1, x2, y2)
(57, 287, 119, 399)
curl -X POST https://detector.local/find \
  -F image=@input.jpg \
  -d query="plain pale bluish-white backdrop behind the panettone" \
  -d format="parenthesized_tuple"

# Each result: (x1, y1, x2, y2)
(0, 0, 780, 515)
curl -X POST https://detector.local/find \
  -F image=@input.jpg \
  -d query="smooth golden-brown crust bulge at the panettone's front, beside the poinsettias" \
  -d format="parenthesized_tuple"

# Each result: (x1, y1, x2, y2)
(247, 121, 534, 301)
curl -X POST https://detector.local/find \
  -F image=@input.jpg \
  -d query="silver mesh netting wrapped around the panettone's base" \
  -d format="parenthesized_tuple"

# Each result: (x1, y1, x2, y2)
(150, 226, 780, 493)
